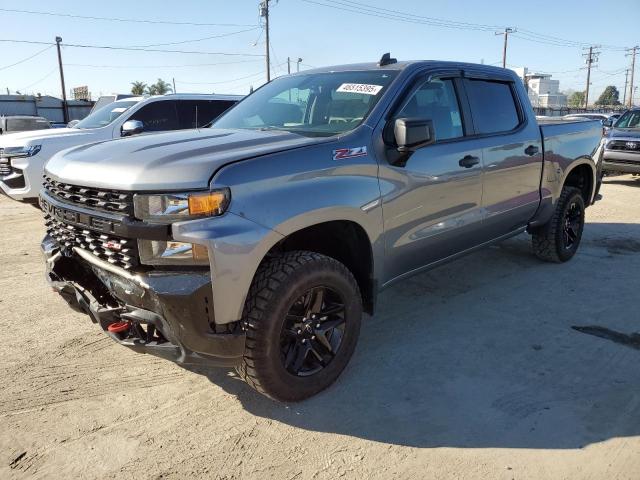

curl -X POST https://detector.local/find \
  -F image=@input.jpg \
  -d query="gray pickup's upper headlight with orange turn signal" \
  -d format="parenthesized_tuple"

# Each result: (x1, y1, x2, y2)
(133, 188, 231, 223)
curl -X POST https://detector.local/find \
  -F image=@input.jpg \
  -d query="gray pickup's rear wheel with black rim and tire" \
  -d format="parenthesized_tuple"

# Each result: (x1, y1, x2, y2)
(531, 187, 585, 263)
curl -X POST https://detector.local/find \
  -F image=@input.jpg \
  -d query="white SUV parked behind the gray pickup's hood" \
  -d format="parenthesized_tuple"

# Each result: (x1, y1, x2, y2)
(0, 94, 242, 201)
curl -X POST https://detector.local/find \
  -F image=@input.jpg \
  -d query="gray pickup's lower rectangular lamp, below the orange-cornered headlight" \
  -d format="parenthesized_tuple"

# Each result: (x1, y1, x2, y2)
(138, 240, 209, 266)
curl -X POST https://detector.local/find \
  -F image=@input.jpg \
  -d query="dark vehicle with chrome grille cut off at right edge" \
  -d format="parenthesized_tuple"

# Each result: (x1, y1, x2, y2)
(602, 108, 640, 174)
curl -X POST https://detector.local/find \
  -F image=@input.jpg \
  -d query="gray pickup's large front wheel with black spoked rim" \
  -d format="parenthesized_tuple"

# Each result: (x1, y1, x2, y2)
(237, 251, 362, 402)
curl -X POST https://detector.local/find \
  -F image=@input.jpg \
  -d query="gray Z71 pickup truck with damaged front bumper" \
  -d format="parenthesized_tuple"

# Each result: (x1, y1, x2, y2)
(40, 55, 601, 401)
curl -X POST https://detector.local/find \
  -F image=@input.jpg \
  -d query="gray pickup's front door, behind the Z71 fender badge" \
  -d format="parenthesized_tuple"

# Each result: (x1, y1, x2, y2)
(380, 72, 482, 283)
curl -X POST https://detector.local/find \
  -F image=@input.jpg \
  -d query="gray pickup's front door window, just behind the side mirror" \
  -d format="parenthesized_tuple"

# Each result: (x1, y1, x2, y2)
(396, 79, 464, 141)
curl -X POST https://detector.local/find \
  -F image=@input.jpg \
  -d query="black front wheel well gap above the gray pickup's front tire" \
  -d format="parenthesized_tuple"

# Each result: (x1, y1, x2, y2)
(269, 220, 376, 314)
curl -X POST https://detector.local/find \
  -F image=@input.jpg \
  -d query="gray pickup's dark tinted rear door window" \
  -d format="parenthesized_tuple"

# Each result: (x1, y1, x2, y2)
(465, 79, 520, 134)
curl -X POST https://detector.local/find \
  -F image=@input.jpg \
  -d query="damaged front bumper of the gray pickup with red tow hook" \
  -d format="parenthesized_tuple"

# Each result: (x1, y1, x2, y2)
(41, 236, 245, 366)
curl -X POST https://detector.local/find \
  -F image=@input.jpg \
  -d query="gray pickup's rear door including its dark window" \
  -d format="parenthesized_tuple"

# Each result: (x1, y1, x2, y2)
(464, 71, 542, 241)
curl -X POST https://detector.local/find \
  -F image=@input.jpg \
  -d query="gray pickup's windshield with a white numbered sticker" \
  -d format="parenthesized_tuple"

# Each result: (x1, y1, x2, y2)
(212, 70, 398, 137)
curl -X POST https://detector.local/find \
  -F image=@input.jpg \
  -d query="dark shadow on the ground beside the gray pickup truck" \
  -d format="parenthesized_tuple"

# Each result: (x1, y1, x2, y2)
(192, 224, 640, 449)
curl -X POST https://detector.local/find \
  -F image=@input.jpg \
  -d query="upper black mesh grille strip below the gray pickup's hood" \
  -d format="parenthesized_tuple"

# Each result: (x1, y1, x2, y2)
(42, 175, 133, 215)
